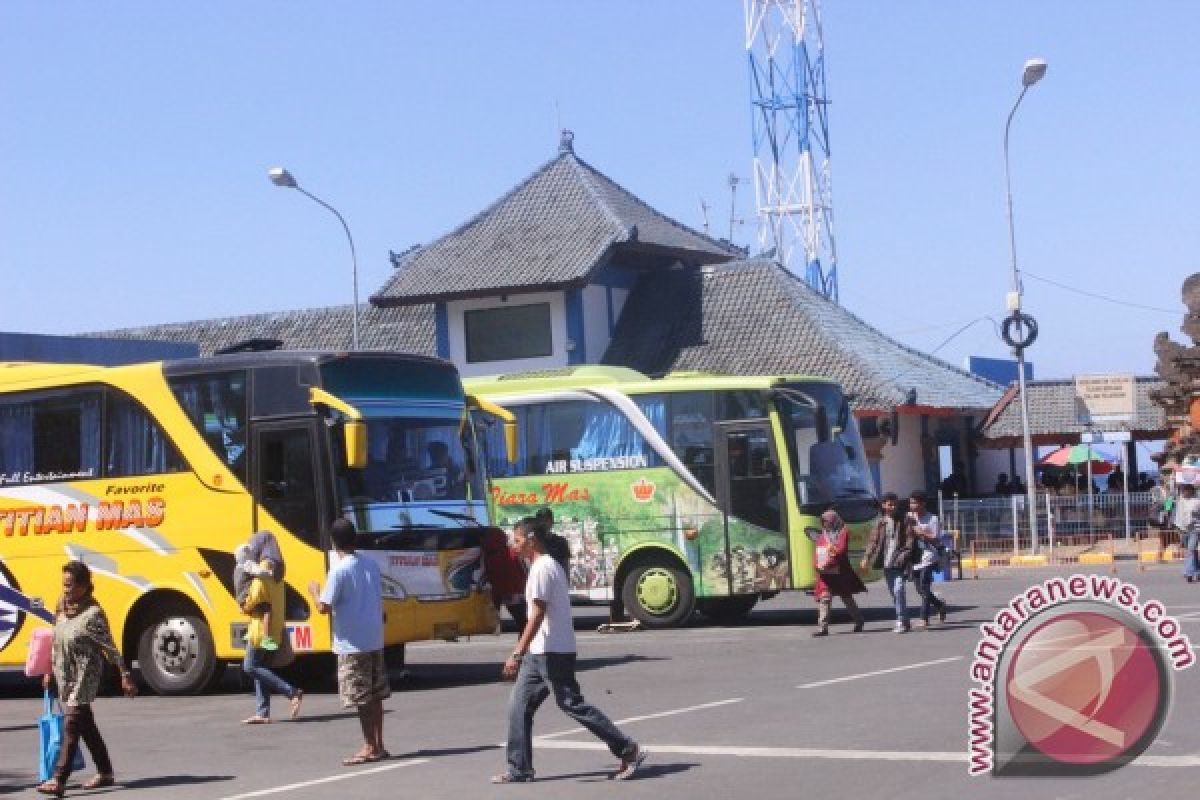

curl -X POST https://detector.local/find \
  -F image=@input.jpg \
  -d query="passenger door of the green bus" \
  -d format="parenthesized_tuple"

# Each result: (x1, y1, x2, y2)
(715, 420, 787, 594)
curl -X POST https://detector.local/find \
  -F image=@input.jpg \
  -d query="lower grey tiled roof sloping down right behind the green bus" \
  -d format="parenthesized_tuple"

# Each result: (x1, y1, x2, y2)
(604, 260, 1002, 410)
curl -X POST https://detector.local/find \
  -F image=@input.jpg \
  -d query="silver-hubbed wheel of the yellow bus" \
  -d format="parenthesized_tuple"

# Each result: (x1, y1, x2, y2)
(138, 603, 217, 694)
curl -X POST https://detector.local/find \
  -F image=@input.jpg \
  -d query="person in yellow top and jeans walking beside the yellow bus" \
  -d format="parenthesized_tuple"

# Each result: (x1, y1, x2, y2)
(234, 530, 304, 724)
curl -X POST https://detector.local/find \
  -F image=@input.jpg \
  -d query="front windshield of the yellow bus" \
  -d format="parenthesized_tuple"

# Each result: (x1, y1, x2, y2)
(338, 416, 486, 533)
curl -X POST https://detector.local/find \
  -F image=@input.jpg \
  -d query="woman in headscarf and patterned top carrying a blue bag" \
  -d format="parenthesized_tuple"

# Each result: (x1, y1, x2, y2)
(37, 561, 138, 798)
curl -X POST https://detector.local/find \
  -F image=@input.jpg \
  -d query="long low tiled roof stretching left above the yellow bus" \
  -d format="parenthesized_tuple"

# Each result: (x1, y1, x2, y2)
(86, 305, 437, 355)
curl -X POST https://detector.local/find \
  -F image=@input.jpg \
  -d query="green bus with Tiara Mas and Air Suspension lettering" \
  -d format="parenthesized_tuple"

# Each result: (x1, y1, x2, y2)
(464, 366, 878, 628)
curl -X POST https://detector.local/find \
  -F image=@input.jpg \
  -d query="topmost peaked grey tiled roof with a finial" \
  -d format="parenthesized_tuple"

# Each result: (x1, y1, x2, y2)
(372, 145, 742, 305)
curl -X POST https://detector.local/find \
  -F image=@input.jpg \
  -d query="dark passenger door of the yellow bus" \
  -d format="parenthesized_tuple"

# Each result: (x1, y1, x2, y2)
(252, 420, 335, 619)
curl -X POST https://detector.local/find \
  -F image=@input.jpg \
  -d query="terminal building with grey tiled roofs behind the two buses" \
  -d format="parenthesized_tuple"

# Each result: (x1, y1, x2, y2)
(75, 132, 1032, 492)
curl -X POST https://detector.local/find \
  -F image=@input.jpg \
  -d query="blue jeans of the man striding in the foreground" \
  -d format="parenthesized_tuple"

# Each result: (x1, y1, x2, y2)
(508, 652, 637, 778)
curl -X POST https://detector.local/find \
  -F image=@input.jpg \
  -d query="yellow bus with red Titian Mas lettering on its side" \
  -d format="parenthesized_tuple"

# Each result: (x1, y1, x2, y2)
(0, 350, 503, 694)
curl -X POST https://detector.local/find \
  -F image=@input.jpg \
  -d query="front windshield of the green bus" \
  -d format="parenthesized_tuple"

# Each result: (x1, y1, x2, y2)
(775, 381, 875, 513)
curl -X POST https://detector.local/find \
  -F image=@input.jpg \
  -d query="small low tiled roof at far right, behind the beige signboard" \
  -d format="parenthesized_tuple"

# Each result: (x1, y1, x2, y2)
(982, 377, 1168, 444)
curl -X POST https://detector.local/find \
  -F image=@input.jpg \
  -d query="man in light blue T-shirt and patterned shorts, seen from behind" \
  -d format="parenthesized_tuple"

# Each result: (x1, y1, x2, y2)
(308, 518, 391, 766)
